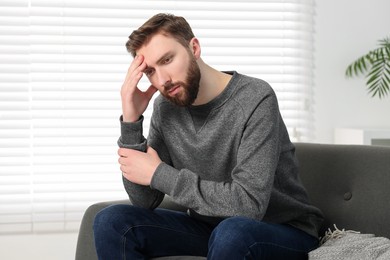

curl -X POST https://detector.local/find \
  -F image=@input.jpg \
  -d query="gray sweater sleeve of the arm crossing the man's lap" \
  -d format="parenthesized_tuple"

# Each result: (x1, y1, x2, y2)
(151, 92, 284, 219)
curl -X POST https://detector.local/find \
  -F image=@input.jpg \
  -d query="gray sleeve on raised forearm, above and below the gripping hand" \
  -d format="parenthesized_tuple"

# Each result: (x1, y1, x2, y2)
(118, 116, 164, 209)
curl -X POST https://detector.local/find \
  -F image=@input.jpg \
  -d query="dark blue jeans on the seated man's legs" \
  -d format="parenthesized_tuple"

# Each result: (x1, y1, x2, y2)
(93, 205, 318, 260)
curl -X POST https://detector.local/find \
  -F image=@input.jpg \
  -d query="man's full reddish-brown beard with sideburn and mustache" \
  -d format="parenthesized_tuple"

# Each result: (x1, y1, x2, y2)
(161, 56, 201, 107)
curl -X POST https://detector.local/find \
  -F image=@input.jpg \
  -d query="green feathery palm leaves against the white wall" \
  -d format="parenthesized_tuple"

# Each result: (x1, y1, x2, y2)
(345, 38, 390, 98)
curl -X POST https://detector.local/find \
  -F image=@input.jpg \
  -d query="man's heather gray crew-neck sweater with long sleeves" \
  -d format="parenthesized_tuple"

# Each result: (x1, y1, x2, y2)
(118, 72, 322, 236)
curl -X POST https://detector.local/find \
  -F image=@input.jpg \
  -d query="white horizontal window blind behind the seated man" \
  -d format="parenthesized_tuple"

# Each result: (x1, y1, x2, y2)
(0, 0, 314, 233)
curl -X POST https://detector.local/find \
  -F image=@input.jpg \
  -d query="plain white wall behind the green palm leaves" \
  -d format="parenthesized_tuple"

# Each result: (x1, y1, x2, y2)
(314, 0, 390, 143)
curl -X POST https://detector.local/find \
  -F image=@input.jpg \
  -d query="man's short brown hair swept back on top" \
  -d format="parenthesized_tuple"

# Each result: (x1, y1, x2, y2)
(126, 13, 195, 57)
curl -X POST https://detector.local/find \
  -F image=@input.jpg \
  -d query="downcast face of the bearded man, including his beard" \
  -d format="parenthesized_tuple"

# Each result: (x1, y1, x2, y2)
(137, 34, 201, 106)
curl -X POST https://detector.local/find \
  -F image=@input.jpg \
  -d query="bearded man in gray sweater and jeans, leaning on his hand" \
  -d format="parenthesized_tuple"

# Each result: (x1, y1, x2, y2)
(94, 14, 322, 260)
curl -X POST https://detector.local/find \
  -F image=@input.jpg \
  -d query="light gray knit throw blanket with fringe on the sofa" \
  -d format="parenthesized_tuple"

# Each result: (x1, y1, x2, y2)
(309, 225, 390, 260)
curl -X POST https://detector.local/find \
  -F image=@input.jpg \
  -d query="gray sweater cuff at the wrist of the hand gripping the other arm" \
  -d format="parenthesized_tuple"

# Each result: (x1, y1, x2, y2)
(150, 162, 179, 195)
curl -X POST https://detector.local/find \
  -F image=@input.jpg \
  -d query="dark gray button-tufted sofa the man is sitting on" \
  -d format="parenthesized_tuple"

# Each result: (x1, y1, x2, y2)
(76, 143, 390, 260)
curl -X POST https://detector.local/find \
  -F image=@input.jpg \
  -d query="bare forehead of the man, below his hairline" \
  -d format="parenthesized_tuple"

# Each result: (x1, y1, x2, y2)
(137, 33, 184, 62)
